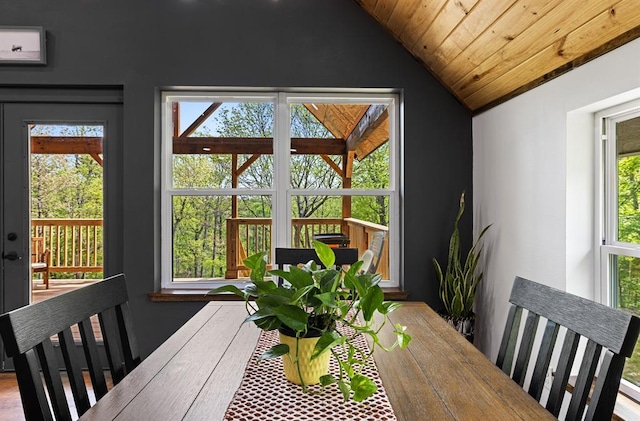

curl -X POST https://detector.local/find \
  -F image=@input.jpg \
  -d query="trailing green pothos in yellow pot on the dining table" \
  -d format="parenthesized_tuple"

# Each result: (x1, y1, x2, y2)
(209, 241, 411, 401)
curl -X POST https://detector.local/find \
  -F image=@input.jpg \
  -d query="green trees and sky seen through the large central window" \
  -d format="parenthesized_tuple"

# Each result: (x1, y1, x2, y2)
(168, 103, 389, 279)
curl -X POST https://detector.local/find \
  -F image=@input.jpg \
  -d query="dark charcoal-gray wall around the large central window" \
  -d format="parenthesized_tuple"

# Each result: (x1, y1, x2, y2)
(0, 0, 472, 354)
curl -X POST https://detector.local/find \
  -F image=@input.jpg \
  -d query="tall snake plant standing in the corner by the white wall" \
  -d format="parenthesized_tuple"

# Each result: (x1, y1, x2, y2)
(433, 191, 491, 342)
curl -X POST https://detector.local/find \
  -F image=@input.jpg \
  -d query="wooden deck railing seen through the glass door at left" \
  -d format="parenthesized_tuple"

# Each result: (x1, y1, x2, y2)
(31, 218, 103, 273)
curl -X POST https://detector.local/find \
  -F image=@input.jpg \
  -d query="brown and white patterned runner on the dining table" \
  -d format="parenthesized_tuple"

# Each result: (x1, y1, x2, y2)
(224, 330, 396, 421)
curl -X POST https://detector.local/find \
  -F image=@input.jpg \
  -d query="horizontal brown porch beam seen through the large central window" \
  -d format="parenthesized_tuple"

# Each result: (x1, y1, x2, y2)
(173, 137, 346, 155)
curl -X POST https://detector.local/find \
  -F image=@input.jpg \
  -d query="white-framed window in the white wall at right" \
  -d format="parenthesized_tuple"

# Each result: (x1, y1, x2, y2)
(596, 101, 640, 394)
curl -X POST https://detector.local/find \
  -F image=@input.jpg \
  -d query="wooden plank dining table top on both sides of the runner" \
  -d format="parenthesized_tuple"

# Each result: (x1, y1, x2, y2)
(80, 301, 555, 421)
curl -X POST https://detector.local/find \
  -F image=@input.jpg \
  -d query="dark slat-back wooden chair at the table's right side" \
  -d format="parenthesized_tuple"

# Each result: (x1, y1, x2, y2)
(497, 277, 640, 420)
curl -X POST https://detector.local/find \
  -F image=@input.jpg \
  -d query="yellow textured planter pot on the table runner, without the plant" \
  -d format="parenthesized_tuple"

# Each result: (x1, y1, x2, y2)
(280, 332, 331, 385)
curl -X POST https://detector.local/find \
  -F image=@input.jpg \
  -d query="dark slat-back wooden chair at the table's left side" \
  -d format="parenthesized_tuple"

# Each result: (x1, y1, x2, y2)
(0, 274, 140, 420)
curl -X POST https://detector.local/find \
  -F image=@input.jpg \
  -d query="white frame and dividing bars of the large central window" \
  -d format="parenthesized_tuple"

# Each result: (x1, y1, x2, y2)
(160, 89, 402, 289)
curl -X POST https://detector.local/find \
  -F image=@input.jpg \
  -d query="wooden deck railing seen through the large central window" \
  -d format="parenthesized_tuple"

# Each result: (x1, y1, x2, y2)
(225, 218, 389, 279)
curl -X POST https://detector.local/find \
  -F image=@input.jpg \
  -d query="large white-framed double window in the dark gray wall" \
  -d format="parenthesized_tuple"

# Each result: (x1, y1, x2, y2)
(161, 92, 400, 288)
